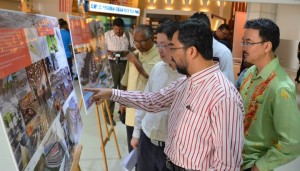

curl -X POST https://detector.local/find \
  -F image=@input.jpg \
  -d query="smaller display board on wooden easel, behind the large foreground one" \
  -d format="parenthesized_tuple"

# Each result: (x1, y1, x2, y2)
(69, 16, 113, 110)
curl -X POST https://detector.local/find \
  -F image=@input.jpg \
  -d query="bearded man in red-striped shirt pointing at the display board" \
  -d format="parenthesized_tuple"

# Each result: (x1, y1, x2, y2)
(85, 19, 244, 171)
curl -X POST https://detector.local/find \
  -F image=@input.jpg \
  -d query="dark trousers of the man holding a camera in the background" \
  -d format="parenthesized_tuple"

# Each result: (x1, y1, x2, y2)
(104, 60, 127, 118)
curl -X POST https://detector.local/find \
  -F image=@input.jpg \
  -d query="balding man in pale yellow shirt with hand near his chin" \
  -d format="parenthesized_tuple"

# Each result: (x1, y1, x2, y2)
(121, 25, 160, 152)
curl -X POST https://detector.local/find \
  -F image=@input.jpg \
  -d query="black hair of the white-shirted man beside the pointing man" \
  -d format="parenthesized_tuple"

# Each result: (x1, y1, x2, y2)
(156, 21, 178, 40)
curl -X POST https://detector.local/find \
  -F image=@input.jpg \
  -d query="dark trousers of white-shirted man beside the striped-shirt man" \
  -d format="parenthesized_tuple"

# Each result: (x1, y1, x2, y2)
(137, 131, 167, 171)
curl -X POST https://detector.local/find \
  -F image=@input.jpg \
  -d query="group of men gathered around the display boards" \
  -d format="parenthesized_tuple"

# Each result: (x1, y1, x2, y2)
(85, 13, 300, 171)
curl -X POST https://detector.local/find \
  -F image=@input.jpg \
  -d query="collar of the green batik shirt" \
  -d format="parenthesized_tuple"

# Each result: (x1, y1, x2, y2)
(252, 56, 279, 80)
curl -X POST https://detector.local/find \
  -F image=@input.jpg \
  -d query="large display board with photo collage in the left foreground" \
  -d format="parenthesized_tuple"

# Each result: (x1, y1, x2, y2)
(0, 9, 82, 171)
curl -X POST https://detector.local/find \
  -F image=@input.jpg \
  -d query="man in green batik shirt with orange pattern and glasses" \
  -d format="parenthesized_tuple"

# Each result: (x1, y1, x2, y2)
(240, 19, 300, 171)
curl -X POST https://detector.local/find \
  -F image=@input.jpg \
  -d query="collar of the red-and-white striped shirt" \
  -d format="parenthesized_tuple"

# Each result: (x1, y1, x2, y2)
(188, 63, 220, 85)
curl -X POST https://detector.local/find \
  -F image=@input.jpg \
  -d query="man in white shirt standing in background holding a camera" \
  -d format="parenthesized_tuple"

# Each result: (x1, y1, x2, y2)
(104, 18, 133, 125)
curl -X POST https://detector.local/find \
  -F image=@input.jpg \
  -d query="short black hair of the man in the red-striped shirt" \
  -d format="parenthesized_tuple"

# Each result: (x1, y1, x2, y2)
(178, 18, 213, 60)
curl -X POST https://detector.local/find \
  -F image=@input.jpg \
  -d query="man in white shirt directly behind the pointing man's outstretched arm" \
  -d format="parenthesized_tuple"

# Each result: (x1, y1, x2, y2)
(131, 21, 184, 171)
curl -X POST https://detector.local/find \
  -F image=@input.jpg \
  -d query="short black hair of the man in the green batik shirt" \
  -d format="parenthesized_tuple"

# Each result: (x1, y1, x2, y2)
(244, 18, 280, 52)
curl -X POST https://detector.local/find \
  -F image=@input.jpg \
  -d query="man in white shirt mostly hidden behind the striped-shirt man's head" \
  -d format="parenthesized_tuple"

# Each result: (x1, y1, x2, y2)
(191, 12, 234, 84)
